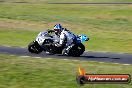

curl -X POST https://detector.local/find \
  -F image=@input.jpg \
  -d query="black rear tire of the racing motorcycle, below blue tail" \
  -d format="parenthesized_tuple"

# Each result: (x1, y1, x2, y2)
(68, 43, 85, 57)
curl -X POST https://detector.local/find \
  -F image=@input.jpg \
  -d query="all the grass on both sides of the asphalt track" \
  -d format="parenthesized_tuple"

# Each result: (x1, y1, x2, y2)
(0, 0, 132, 88)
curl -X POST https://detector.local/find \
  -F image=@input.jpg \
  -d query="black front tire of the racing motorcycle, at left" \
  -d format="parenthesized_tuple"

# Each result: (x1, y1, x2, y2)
(28, 41, 43, 54)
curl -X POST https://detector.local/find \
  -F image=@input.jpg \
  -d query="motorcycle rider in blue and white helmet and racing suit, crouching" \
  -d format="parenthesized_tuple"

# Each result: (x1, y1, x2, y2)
(54, 24, 76, 55)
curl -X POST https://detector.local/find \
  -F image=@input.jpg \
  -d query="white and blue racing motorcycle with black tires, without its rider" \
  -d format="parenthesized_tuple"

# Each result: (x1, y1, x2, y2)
(28, 30, 89, 57)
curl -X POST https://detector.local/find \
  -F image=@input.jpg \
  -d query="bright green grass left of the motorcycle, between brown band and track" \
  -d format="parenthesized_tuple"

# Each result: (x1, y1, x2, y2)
(0, 29, 38, 47)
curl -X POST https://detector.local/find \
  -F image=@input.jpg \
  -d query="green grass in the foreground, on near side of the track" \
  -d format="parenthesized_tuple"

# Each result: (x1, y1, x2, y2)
(0, 54, 132, 88)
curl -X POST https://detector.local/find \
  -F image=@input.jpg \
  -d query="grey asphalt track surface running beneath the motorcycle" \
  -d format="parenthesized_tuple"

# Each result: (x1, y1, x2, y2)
(0, 46, 132, 64)
